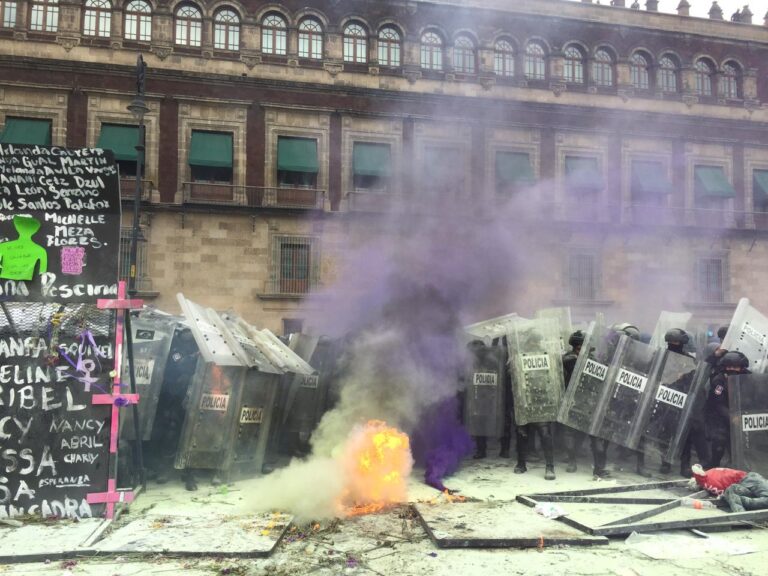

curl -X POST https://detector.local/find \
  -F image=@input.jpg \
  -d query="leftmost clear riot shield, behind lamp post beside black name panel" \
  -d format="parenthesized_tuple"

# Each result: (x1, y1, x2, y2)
(120, 310, 180, 441)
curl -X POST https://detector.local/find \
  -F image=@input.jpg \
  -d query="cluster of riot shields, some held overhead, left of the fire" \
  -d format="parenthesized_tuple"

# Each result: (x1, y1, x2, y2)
(120, 294, 337, 485)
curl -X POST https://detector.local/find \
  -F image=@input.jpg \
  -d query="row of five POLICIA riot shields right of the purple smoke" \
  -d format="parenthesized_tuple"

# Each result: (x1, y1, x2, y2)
(464, 314, 728, 470)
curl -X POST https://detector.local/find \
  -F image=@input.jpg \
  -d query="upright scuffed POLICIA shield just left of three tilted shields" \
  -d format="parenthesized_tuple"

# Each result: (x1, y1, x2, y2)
(507, 318, 563, 425)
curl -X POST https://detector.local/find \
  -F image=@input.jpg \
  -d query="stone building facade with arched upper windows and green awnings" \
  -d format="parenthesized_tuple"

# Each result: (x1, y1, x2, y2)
(0, 0, 768, 332)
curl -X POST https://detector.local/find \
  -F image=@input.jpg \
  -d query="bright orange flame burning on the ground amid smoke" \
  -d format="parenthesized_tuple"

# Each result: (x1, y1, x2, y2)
(341, 420, 413, 516)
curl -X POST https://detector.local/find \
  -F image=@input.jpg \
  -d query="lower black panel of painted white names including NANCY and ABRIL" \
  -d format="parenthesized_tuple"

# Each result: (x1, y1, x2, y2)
(0, 303, 114, 518)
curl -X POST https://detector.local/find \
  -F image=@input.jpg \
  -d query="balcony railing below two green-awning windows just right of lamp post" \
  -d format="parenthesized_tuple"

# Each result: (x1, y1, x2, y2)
(183, 182, 325, 210)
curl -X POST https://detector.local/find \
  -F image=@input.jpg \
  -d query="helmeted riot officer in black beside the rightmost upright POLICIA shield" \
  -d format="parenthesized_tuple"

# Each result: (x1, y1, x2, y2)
(704, 350, 750, 468)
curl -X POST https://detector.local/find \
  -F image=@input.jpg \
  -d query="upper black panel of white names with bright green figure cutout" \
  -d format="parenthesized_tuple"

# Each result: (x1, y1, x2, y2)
(0, 144, 120, 302)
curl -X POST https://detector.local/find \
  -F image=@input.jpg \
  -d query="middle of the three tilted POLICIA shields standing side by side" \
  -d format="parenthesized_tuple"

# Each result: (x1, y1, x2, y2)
(593, 336, 663, 449)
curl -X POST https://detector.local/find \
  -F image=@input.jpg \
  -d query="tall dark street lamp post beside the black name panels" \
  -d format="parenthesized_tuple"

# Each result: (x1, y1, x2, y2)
(125, 54, 149, 489)
